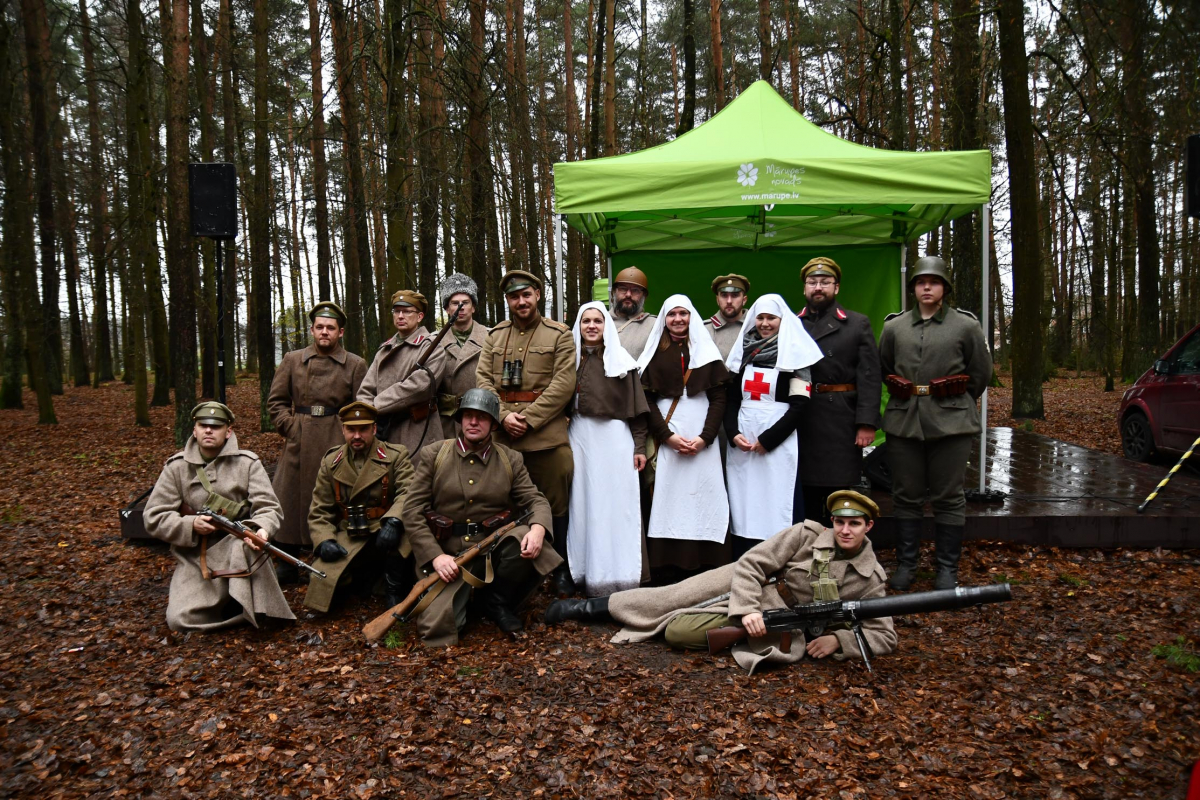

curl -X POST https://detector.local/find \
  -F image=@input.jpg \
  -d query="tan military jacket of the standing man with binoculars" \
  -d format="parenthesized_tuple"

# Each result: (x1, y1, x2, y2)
(475, 317, 575, 452)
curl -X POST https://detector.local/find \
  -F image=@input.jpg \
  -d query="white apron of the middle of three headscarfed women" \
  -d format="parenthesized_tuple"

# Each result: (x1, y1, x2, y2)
(646, 391, 730, 543)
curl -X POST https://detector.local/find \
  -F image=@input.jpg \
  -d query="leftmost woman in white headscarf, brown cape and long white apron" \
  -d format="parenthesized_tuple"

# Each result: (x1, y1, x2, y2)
(566, 302, 649, 597)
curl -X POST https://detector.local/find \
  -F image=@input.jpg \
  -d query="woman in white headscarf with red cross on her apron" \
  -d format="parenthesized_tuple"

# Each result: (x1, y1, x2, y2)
(725, 294, 823, 558)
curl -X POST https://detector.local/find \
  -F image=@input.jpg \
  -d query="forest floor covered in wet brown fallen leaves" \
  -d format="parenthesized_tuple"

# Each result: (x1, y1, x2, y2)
(0, 378, 1200, 800)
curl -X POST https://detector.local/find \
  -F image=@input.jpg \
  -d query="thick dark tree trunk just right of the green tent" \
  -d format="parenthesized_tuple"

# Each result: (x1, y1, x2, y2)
(997, 0, 1045, 420)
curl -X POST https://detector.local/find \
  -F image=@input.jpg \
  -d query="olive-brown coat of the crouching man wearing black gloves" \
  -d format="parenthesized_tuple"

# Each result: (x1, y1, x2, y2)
(304, 439, 413, 612)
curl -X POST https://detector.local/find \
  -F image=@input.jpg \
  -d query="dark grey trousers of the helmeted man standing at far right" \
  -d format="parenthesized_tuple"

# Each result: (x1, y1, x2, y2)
(888, 433, 974, 525)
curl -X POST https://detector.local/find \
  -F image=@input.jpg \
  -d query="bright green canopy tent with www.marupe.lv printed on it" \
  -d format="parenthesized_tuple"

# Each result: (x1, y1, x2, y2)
(554, 80, 991, 494)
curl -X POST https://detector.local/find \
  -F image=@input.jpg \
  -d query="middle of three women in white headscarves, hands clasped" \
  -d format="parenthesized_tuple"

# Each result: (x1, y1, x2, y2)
(637, 294, 731, 575)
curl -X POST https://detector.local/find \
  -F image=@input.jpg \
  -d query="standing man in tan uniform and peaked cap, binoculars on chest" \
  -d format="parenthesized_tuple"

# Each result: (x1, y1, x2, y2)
(475, 270, 575, 595)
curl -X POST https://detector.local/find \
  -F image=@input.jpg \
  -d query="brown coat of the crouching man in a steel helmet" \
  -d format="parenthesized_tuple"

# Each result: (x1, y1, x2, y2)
(403, 440, 563, 648)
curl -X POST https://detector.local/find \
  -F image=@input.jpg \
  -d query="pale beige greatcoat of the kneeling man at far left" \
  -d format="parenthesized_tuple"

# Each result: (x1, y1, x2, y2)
(144, 435, 295, 631)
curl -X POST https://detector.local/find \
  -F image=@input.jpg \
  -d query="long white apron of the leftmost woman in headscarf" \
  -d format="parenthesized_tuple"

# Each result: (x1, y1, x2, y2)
(566, 414, 642, 597)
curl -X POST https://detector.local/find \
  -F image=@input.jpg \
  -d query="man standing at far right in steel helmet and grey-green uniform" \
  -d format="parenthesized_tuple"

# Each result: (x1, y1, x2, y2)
(880, 255, 991, 590)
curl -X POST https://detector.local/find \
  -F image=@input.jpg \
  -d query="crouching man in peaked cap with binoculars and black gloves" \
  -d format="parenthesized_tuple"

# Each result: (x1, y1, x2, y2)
(304, 402, 413, 612)
